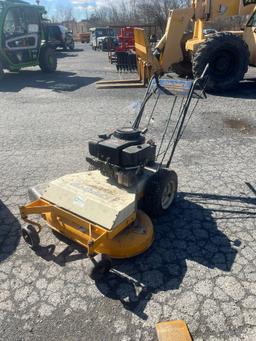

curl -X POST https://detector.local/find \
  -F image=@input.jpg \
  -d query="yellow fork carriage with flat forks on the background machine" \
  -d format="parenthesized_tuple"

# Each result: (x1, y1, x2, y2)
(96, 28, 160, 89)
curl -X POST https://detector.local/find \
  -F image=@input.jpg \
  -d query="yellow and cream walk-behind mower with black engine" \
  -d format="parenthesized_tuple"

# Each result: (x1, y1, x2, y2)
(20, 65, 208, 279)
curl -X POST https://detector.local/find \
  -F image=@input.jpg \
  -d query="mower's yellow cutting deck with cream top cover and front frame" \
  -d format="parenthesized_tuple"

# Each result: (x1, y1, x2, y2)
(20, 171, 153, 258)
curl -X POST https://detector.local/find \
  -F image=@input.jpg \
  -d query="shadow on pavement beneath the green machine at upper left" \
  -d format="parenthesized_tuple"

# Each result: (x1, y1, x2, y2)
(0, 70, 101, 92)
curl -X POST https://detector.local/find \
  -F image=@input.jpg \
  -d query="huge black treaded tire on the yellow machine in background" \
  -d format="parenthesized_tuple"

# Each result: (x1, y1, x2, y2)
(192, 32, 249, 91)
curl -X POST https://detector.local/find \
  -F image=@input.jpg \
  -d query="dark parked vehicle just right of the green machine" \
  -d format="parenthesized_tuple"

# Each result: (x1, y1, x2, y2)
(45, 23, 75, 51)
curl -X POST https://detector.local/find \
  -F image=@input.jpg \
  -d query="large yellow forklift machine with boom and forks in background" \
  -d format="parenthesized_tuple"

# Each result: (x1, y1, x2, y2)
(98, 0, 256, 91)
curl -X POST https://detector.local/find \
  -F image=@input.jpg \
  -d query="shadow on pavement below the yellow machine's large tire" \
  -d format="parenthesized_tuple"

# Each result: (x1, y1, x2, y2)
(211, 78, 256, 99)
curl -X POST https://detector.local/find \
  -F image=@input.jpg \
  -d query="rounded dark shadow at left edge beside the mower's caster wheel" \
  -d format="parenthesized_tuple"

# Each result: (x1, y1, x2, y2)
(0, 200, 21, 262)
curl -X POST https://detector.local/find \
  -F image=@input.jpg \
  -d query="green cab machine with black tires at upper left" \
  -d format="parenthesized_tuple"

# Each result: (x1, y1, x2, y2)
(0, 0, 57, 78)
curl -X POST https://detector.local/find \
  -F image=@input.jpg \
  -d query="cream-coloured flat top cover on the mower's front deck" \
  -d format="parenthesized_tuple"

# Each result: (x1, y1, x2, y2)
(38, 170, 136, 231)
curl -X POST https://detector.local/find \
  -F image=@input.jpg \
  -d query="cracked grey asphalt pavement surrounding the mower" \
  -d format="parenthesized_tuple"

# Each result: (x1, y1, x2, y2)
(0, 45, 256, 341)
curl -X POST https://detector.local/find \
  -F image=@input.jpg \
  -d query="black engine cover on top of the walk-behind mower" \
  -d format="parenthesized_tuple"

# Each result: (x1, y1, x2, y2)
(89, 128, 156, 168)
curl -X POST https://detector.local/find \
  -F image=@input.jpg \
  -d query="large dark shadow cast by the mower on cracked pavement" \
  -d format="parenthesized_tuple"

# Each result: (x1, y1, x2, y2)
(96, 193, 256, 319)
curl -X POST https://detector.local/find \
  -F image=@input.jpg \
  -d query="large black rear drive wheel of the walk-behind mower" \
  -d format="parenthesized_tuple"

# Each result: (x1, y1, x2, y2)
(142, 168, 178, 217)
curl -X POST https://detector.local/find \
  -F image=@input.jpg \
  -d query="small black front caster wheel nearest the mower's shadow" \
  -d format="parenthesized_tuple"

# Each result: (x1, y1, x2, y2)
(88, 253, 112, 281)
